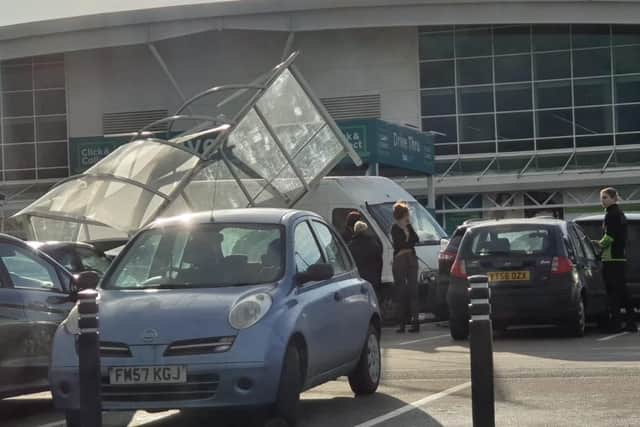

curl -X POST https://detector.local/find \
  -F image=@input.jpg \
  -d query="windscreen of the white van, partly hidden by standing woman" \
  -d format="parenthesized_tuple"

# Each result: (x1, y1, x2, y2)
(368, 202, 447, 245)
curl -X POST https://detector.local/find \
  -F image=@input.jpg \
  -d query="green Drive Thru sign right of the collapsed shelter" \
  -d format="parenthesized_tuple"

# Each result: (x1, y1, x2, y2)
(338, 119, 434, 175)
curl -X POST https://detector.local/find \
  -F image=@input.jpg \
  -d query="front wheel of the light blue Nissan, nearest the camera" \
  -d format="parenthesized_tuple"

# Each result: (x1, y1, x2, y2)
(274, 344, 302, 427)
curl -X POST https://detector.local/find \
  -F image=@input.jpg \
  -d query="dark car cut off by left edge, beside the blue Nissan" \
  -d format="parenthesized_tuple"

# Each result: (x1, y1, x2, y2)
(0, 234, 74, 398)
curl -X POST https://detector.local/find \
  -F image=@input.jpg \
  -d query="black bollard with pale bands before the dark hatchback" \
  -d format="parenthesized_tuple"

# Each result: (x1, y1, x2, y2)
(469, 275, 496, 427)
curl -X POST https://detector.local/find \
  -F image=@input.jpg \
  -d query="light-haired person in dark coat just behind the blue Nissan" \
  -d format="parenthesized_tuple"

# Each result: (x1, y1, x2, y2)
(349, 221, 382, 291)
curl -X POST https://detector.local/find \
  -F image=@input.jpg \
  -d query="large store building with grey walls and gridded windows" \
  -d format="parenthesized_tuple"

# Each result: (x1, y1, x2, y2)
(0, 0, 640, 234)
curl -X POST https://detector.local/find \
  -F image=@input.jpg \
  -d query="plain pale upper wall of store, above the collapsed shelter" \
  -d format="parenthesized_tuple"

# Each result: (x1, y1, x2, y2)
(65, 28, 420, 137)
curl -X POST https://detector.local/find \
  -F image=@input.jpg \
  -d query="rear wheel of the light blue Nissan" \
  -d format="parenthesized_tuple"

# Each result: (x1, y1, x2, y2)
(349, 325, 382, 396)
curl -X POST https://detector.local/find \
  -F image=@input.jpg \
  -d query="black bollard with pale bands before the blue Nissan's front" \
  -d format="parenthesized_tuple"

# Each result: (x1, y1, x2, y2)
(78, 289, 102, 427)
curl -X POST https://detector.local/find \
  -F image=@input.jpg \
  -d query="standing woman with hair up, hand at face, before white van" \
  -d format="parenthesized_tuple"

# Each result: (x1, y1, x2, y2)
(391, 202, 420, 333)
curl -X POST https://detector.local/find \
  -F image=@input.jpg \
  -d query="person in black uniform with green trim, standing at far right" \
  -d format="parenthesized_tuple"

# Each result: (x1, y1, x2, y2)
(597, 187, 638, 332)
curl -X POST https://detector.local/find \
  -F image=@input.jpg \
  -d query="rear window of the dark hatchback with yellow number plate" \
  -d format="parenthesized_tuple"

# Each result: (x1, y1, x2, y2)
(464, 224, 554, 257)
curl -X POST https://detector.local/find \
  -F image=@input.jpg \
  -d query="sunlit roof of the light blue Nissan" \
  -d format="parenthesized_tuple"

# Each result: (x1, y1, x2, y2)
(148, 208, 322, 228)
